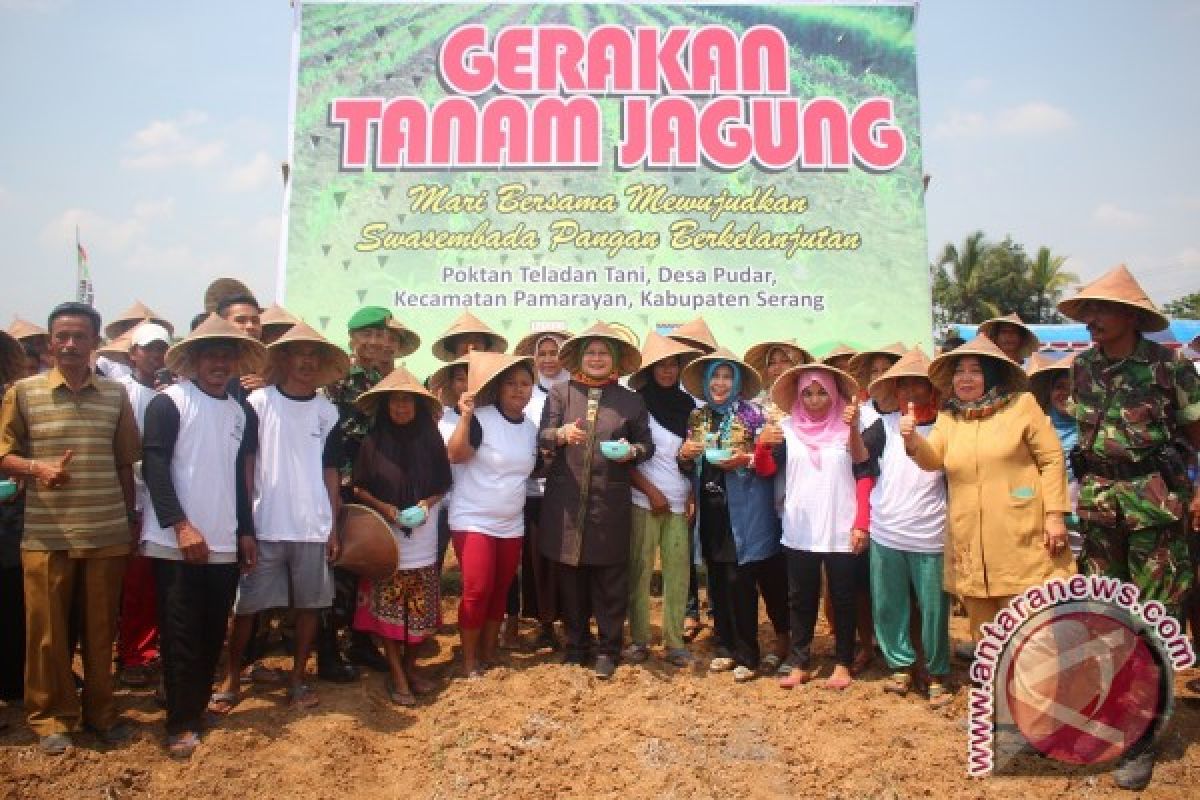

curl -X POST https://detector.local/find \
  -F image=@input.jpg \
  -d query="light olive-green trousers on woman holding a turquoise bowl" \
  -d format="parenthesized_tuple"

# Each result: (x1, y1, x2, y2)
(629, 505, 691, 650)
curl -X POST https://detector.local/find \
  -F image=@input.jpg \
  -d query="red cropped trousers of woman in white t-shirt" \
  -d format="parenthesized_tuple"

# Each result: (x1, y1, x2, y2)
(450, 530, 521, 631)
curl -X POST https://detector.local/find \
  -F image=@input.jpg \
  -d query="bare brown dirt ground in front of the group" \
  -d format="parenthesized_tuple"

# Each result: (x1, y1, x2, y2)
(0, 597, 1200, 800)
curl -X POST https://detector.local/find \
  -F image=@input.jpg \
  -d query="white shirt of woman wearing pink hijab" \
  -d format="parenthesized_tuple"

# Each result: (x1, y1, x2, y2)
(780, 416, 858, 553)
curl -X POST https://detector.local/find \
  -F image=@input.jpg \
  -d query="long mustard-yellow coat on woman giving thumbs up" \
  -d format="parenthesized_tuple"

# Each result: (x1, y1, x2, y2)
(911, 392, 1075, 597)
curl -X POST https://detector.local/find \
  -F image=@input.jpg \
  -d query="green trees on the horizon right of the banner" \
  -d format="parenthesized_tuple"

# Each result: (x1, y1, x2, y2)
(930, 230, 1200, 330)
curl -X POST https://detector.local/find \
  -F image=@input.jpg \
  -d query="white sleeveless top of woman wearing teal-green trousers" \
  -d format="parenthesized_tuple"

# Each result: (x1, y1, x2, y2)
(871, 411, 946, 553)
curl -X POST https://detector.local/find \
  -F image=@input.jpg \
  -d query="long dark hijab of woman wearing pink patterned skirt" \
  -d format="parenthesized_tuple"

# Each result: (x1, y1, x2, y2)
(354, 398, 452, 509)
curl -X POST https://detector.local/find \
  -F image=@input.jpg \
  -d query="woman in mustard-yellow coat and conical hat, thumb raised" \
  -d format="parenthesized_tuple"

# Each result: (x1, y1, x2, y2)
(900, 336, 1075, 639)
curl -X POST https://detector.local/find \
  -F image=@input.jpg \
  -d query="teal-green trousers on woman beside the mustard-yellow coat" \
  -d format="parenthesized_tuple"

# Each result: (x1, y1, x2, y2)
(871, 541, 950, 676)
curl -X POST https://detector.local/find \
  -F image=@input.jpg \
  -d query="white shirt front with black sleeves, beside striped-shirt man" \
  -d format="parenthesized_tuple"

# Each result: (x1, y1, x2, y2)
(139, 380, 246, 553)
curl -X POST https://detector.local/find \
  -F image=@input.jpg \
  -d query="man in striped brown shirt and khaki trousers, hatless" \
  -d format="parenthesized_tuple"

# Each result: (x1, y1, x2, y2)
(0, 302, 142, 754)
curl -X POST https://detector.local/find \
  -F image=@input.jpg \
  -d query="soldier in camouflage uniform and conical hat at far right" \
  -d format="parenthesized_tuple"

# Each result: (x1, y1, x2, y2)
(1058, 266, 1200, 789)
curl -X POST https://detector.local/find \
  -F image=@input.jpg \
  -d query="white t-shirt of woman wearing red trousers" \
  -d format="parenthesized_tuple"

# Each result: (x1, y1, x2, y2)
(450, 405, 538, 539)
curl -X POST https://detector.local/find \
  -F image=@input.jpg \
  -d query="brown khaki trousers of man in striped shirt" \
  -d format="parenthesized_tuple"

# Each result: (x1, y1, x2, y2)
(20, 551, 128, 736)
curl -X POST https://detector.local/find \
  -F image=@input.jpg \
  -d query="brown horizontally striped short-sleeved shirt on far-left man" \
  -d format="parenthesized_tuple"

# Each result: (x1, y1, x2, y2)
(0, 368, 142, 555)
